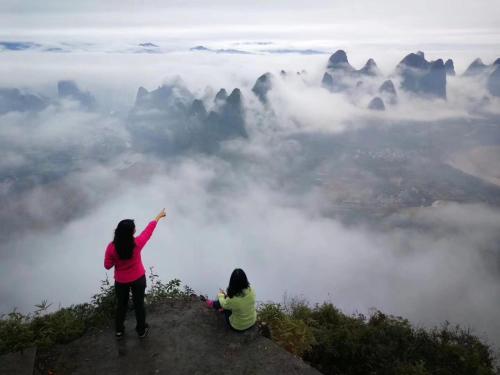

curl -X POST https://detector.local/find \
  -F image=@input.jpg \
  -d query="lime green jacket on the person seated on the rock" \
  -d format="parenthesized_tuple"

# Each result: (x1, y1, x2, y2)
(218, 288, 257, 331)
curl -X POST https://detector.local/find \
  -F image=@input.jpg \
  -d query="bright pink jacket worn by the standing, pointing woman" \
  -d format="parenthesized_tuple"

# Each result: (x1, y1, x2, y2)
(104, 220, 157, 283)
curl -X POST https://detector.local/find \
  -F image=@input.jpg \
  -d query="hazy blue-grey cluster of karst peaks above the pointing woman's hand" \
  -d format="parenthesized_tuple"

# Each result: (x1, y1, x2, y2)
(128, 81, 247, 155)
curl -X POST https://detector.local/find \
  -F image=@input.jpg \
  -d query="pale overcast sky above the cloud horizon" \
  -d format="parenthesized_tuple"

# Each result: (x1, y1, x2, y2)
(0, 0, 500, 44)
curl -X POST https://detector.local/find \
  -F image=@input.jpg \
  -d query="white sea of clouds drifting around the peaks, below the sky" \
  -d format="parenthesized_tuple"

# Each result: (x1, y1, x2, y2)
(0, 33, 500, 356)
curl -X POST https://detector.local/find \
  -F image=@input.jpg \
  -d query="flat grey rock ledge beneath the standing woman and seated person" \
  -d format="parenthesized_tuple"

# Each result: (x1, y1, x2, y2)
(47, 300, 319, 375)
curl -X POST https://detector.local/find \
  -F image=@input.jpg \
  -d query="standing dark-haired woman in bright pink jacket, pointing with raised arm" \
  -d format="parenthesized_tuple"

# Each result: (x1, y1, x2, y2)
(104, 209, 166, 339)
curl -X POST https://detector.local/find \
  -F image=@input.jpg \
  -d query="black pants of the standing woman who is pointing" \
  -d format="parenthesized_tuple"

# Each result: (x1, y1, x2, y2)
(115, 275, 146, 334)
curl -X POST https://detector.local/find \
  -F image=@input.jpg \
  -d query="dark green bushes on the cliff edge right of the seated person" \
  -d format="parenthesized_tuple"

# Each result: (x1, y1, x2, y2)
(259, 302, 498, 375)
